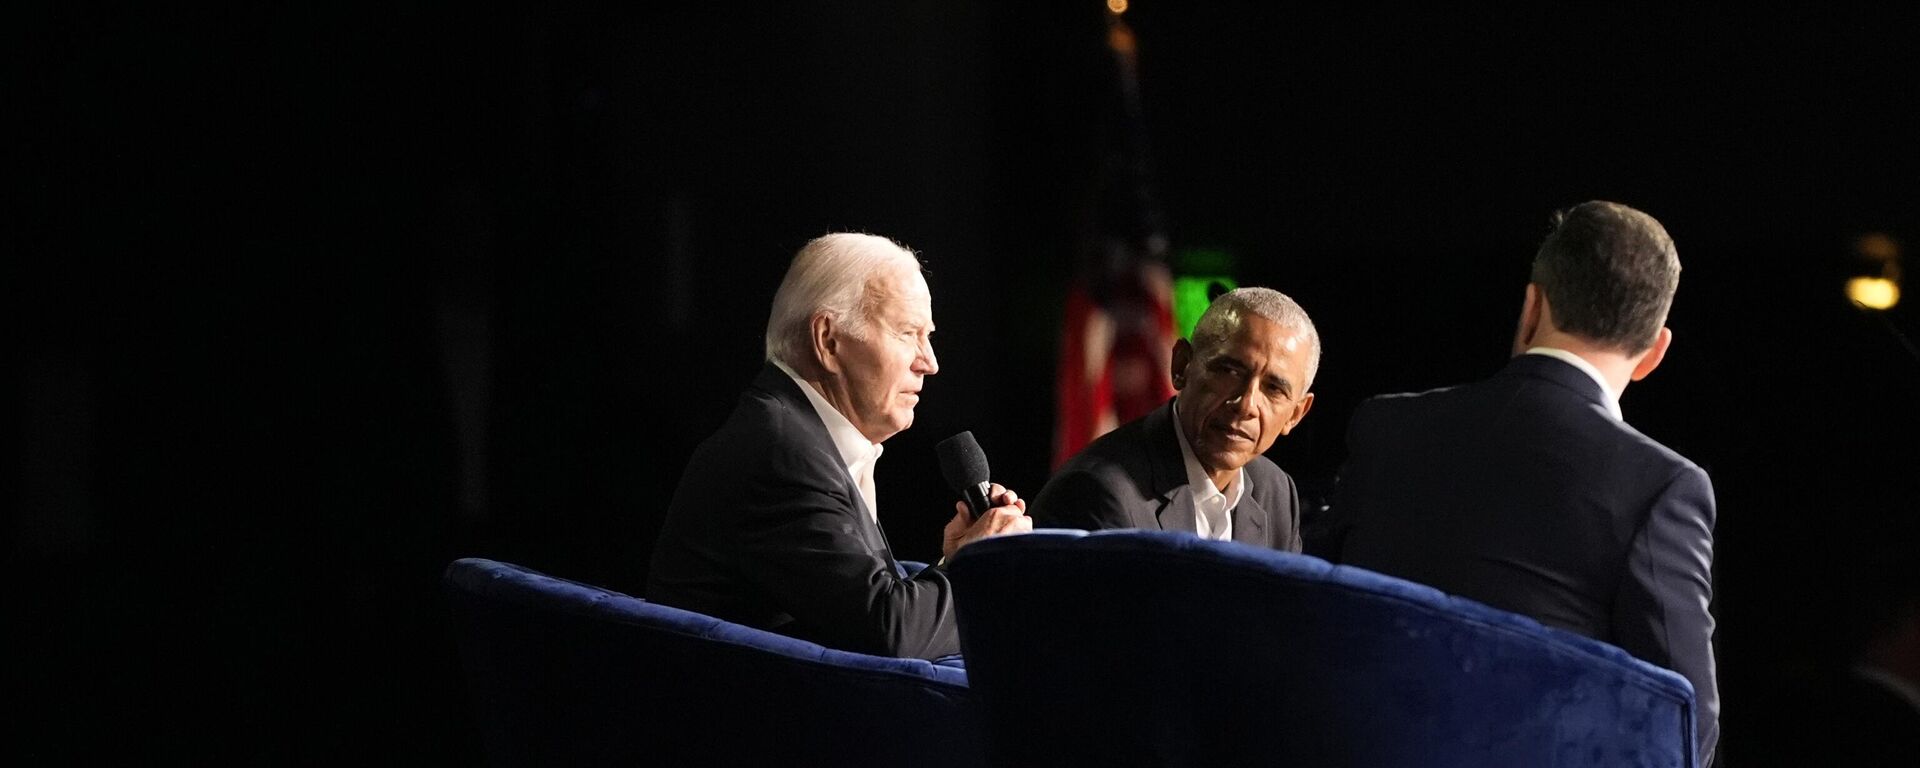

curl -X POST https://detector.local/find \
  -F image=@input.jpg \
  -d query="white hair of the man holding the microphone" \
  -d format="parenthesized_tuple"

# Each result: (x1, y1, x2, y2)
(766, 232, 920, 369)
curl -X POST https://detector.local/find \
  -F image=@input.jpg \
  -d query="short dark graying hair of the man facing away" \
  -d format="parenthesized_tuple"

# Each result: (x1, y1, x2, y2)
(1532, 200, 1680, 355)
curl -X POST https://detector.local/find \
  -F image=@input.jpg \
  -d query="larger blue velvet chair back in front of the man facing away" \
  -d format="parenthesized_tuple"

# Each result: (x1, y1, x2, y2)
(948, 530, 1693, 768)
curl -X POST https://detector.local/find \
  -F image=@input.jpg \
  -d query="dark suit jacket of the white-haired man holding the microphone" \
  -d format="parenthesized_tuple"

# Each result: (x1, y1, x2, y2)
(647, 365, 960, 659)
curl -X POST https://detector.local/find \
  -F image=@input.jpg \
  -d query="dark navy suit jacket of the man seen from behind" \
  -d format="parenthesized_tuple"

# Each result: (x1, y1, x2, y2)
(1308, 355, 1718, 766)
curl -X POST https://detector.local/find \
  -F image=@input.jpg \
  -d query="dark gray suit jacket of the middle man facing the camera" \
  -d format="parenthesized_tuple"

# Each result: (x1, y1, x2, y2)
(1027, 401, 1300, 551)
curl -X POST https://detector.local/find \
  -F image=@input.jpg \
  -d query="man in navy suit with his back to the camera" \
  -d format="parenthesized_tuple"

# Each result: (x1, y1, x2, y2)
(1308, 200, 1720, 766)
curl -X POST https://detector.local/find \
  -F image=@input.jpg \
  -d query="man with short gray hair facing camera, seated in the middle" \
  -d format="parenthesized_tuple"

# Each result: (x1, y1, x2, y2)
(1033, 288, 1319, 551)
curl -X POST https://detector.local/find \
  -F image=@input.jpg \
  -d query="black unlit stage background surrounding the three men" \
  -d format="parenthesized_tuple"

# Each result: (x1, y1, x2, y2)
(18, 0, 1920, 764)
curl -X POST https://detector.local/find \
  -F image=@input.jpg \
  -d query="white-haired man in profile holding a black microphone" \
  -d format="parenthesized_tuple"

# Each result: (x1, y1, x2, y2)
(647, 232, 1033, 659)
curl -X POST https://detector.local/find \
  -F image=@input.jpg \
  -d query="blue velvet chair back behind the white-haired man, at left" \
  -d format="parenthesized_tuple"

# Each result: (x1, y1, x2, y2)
(444, 559, 983, 768)
